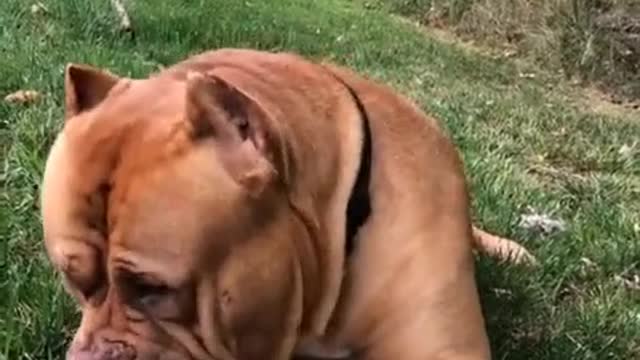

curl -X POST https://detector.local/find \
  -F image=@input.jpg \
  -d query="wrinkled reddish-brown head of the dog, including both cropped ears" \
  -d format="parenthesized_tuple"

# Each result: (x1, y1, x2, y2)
(42, 65, 307, 360)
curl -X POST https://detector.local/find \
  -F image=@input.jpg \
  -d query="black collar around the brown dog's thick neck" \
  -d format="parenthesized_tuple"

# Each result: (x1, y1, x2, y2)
(339, 79, 371, 258)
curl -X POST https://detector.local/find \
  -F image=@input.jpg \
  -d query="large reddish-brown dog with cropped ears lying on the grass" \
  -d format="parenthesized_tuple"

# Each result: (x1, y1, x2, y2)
(42, 49, 530, 360)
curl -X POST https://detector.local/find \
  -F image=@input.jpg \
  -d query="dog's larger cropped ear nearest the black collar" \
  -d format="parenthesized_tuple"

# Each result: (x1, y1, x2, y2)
(186, 72, 277, 193)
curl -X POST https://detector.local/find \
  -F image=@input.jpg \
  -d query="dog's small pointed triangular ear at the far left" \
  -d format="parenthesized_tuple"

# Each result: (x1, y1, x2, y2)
(64, 64, 120, 121)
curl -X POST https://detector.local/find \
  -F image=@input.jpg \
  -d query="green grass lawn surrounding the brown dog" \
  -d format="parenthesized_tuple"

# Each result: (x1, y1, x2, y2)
(0, 0, 640, 360)
